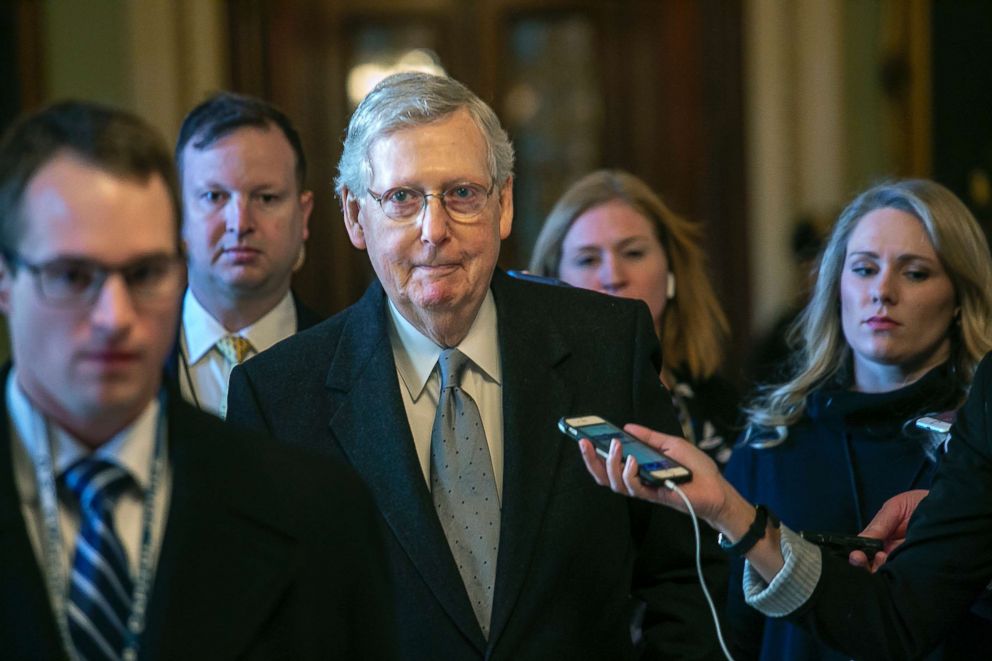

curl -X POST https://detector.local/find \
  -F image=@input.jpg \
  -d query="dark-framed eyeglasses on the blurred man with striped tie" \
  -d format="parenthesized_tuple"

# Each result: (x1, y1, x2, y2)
(4, 252, 183, 307)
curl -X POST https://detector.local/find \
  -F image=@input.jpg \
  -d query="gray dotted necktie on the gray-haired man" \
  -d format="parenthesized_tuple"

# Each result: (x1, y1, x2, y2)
(431, 349, 499, 638)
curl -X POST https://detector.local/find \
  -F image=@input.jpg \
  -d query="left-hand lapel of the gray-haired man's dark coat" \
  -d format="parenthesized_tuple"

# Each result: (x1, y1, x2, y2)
(327, 282, 485, 650)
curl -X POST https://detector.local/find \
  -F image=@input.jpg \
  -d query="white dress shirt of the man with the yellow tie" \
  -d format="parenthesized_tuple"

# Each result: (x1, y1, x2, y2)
(178, 289, 296, 418)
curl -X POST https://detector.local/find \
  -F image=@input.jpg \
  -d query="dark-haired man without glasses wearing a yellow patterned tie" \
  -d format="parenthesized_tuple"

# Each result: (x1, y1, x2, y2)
(167, 92, 321, 418)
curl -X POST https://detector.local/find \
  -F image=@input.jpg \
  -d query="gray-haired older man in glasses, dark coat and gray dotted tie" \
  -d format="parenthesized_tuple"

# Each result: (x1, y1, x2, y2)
(229, 69, 723, 660)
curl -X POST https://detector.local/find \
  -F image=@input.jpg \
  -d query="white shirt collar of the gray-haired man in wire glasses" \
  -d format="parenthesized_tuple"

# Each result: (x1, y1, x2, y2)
(388, 291, 503, 401)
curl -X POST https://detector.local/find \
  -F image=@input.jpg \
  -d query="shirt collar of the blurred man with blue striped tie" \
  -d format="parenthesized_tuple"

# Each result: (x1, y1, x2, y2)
(6, 367, 161, 496)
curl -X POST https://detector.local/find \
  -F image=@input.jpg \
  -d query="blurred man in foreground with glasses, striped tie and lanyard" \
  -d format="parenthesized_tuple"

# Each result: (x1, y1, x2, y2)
(0, 102, 392, 660)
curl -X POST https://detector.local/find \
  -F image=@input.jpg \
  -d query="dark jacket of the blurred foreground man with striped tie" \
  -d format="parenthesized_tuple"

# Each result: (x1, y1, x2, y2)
(0, 372, 394, 661)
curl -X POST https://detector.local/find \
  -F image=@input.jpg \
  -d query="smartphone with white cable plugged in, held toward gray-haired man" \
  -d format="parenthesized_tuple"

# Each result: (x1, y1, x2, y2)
(558, 415, 692, 487)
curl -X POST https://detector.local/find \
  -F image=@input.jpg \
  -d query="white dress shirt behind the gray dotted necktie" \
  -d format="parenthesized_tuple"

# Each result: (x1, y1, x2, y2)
(389, 292, 503, 502)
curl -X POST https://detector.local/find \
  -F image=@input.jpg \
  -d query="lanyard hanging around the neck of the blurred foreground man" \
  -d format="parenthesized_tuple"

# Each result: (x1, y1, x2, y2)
(34, 395, 165, 661)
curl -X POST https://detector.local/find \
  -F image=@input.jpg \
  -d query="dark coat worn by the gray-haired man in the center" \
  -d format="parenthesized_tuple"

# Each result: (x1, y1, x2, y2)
(228, 272, 725, 661)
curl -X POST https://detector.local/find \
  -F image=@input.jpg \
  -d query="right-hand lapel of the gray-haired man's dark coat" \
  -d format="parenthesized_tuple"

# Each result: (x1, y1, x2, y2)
(491, 271, 572, 640)
